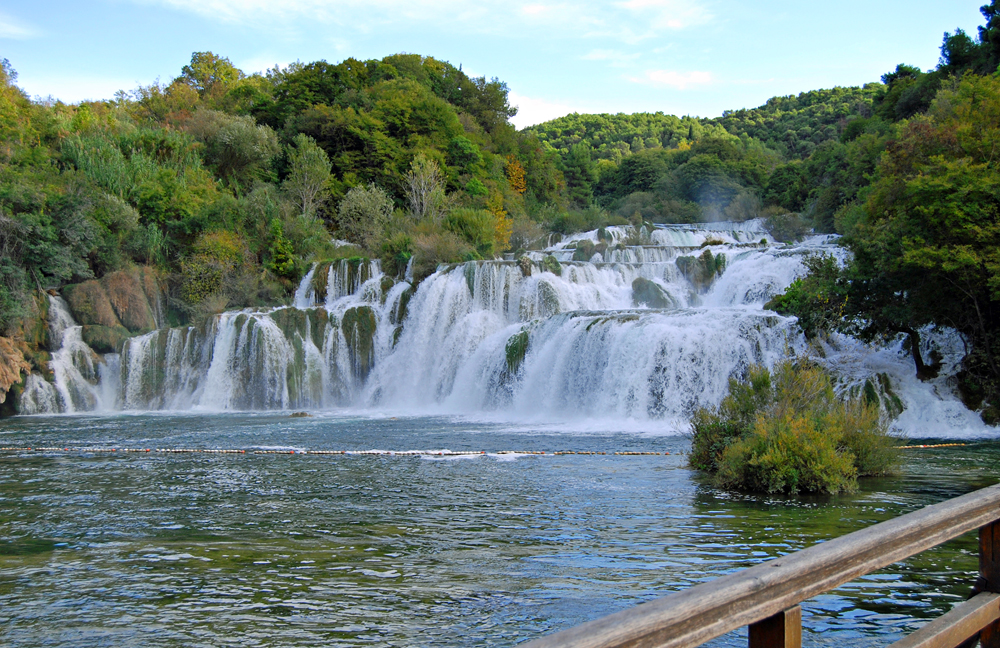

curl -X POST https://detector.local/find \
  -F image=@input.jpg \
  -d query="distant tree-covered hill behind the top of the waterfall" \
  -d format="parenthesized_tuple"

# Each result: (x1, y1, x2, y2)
(527, 83, 888, 228)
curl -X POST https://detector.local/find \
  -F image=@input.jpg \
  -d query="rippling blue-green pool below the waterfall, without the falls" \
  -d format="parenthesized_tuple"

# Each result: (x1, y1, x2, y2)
(0, 415, 1000, 647)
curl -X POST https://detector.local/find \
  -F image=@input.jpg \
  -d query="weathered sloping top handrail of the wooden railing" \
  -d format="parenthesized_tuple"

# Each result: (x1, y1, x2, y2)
(524, 485, 1000, 648)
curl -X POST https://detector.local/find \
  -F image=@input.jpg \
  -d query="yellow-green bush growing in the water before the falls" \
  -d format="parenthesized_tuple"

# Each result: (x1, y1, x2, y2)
(689, 361, 899, 493)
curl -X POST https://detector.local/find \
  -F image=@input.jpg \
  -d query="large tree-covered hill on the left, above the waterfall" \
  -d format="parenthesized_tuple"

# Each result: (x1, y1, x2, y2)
(0, 52, 564, 350)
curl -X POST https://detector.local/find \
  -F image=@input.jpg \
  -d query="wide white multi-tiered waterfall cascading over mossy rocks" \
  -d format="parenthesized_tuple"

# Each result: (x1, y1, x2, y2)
(20, 221, 996, 438)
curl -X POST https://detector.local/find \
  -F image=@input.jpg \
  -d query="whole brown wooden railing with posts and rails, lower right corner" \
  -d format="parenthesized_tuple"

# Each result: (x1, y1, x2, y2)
(521, 485, 1000, 648)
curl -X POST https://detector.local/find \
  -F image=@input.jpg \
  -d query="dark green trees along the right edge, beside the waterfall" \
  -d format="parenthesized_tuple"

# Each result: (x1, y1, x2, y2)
(769, 2, 1000, 425)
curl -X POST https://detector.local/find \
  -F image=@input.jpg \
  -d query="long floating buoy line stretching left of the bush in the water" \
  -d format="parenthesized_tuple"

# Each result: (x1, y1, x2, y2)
(0, 446, 672, 457)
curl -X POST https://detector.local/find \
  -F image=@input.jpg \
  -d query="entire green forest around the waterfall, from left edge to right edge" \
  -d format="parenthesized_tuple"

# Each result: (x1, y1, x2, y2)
(0, 1, 1000, 417)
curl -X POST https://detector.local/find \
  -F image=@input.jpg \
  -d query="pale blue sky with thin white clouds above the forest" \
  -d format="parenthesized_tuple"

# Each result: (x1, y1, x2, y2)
(0, 0, 985, 126)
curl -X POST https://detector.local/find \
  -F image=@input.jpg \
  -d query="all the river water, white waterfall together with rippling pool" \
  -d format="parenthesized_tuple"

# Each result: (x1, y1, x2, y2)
(7, 222, 1000, 648)
